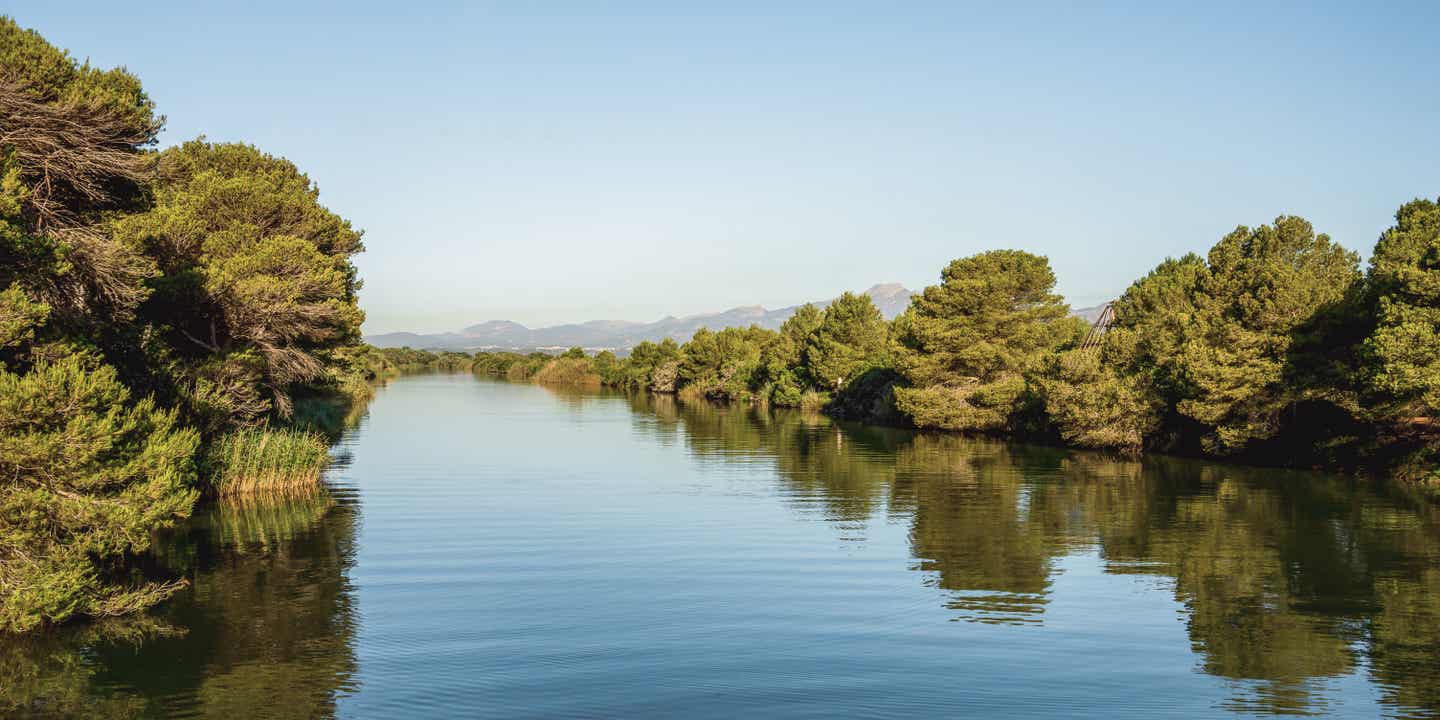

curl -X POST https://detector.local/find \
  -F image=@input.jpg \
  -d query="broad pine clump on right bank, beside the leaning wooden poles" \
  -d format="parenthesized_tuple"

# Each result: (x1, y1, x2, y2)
(1043, 216, 1359, 455)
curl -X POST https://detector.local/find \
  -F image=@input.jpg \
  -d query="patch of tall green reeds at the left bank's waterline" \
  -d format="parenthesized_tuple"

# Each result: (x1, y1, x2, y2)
(204, 428, 330, 495)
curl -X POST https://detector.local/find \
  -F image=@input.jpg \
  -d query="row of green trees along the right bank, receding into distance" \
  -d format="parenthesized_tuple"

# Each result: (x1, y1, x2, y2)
(474, 208, 1440, 480)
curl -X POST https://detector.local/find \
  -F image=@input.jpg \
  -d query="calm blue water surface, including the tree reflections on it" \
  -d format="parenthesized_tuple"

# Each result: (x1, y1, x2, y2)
(0, 376, 1440, 719)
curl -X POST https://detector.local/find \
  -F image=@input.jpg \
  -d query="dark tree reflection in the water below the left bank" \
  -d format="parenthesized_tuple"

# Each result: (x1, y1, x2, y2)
(0, 491, 357, 719)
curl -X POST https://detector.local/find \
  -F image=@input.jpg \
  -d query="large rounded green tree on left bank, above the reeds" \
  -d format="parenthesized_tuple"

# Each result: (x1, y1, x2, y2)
(117, 140, 364, 423)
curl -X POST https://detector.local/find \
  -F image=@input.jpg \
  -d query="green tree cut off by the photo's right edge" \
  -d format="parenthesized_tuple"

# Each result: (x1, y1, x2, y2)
(1362, 200, 1440, 420)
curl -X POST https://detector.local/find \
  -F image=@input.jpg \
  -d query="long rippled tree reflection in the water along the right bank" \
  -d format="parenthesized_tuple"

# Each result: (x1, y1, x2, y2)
(631, 396, 1440, 713)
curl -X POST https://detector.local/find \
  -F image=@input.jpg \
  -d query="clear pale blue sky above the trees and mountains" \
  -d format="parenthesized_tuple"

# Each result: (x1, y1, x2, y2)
(14, 0, 1440, 333)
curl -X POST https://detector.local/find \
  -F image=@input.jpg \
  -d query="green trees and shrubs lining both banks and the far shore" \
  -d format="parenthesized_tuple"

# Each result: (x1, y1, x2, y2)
(0, 16, 1440, 632)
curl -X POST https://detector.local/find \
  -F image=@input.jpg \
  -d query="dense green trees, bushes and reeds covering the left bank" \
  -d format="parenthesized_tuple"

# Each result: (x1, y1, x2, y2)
(0, 16, 399, 632)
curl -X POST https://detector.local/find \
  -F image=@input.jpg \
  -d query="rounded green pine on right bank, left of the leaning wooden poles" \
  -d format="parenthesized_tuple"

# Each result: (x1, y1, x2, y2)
(891, 251, 1076, 431)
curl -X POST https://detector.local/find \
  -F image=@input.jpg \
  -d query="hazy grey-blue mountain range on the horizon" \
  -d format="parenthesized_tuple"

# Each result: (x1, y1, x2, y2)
(364, 282, 1100, 351)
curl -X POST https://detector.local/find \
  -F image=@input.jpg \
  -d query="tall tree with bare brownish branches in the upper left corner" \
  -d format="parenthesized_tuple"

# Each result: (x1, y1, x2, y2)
(0, 16, 163, 336)
